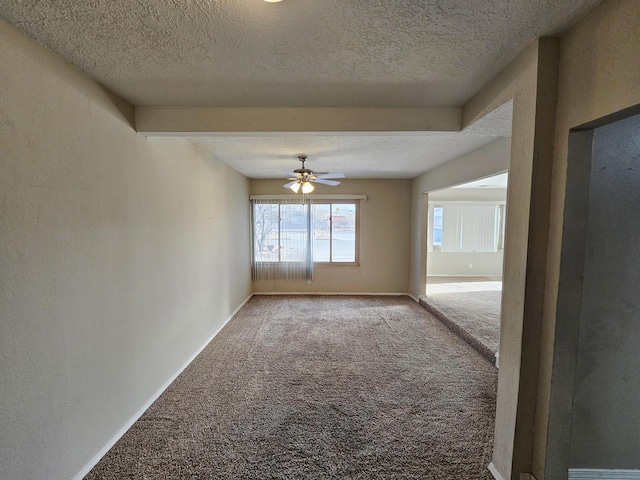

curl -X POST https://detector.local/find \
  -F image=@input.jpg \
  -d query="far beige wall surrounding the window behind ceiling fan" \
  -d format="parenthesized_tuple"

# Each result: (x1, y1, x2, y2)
(251, 179, 411, 293)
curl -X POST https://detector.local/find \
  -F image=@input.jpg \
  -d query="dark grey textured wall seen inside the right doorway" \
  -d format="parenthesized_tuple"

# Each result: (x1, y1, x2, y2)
(568, 111, 640, 470)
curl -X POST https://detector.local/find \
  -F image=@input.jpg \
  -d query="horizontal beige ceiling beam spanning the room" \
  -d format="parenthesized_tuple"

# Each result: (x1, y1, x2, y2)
(136, 107, 462, 137)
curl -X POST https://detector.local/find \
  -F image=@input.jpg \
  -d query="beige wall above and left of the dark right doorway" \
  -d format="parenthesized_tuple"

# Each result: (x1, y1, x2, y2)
(534, 0, 640, 480)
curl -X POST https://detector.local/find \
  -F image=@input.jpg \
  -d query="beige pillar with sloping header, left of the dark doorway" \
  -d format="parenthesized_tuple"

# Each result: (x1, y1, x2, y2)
(463, 39, 557, 479)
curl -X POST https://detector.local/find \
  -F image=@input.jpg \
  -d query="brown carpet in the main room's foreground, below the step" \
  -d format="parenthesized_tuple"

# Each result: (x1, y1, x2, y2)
(85, 296, 497, 480)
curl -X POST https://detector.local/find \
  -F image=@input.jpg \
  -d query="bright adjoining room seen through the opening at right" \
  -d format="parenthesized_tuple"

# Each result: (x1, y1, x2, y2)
(420, 172, 508, 366)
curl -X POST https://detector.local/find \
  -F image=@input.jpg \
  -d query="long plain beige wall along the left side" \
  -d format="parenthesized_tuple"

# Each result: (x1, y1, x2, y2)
(0, 20, 251, 480)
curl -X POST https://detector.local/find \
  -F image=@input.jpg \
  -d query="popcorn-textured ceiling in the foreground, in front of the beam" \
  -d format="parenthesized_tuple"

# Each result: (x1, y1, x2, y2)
(0, 0, 599, 107)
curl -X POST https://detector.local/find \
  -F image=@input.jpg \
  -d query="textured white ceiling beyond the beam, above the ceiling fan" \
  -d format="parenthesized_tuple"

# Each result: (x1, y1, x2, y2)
(190, 102, 513, 178)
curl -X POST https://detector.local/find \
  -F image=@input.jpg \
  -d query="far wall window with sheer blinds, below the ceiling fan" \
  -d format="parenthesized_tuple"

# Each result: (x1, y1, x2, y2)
(252, 197, 359, 280)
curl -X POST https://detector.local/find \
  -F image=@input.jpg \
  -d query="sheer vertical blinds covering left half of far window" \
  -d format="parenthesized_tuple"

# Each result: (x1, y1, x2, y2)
(251, 195, 313, 282)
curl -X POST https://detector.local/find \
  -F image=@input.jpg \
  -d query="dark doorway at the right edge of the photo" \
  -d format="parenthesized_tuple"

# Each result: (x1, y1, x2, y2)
(546, 108, 640, 480)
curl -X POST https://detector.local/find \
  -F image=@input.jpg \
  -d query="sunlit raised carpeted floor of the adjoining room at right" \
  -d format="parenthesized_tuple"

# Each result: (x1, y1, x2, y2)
(420, 277, 502, 361)
